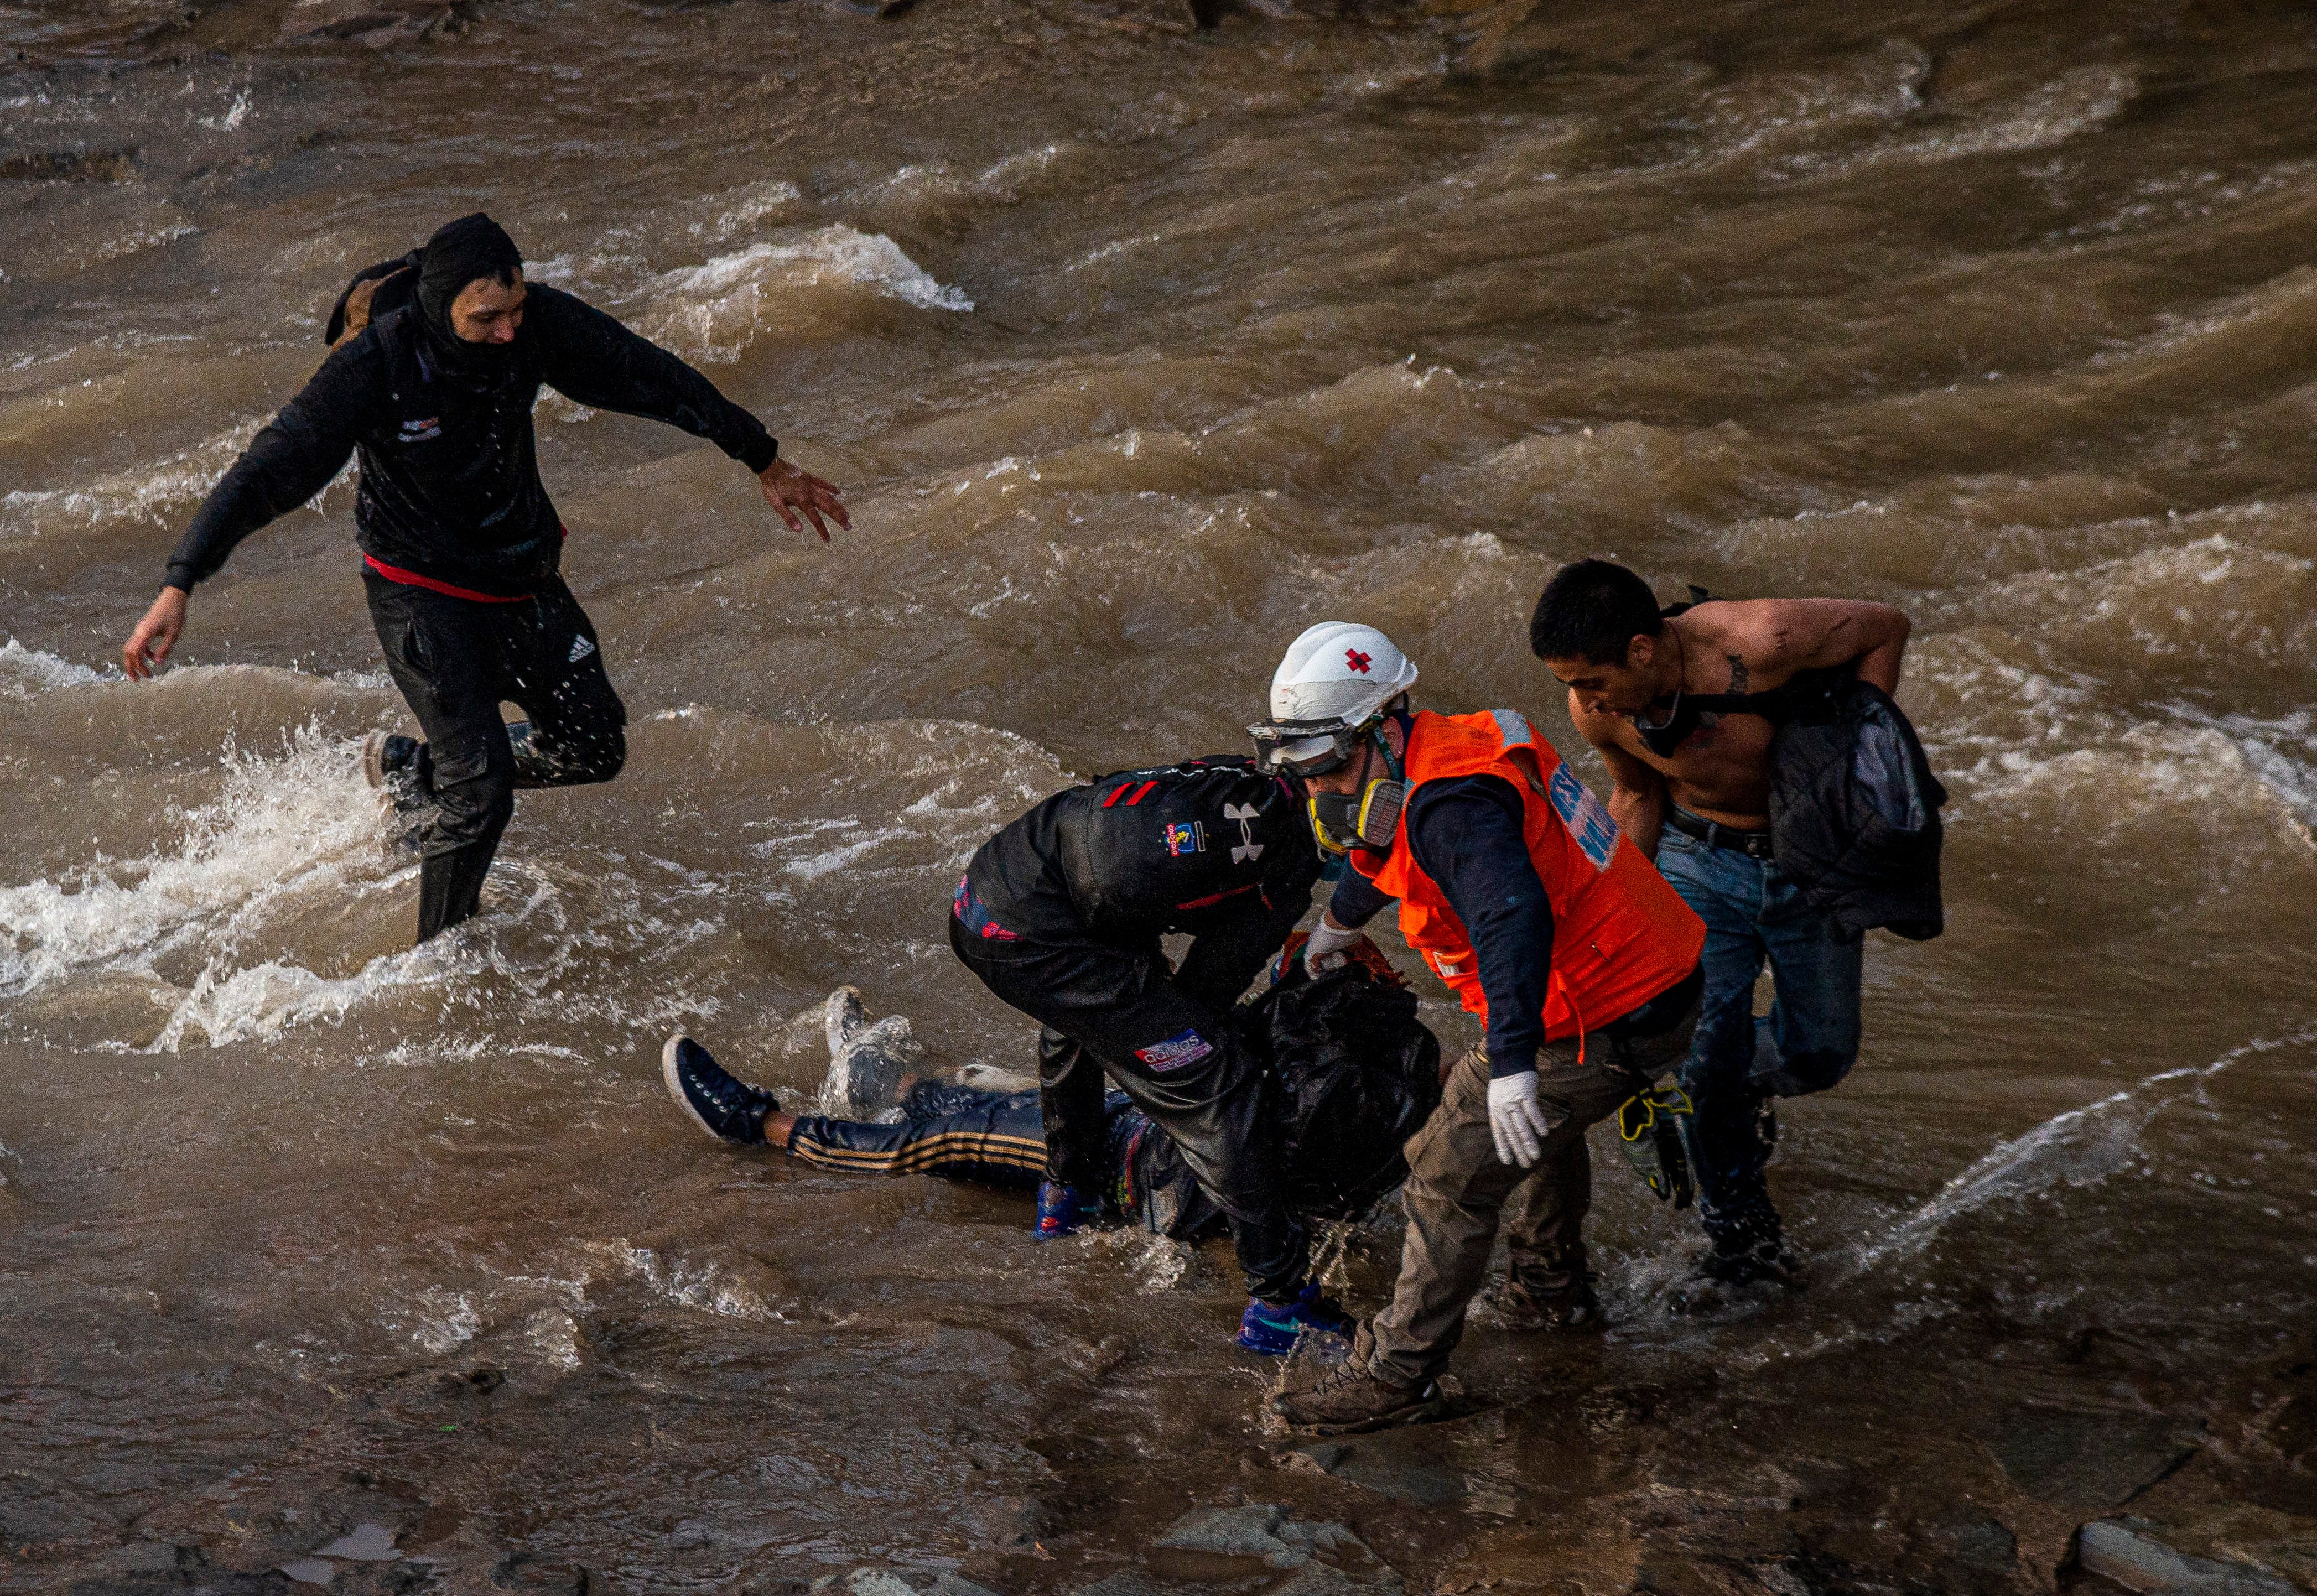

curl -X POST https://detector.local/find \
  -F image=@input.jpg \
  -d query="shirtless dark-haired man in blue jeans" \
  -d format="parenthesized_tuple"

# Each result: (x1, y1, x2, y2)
(1529, 560, 1909, 1286)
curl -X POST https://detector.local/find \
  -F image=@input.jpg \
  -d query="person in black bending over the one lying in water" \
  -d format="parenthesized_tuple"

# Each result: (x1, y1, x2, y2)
(950, 732, 1351, 1355)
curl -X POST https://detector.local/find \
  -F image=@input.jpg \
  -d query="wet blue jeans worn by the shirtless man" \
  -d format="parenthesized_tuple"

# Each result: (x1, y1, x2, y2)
(1656, 827, 1865, 1241)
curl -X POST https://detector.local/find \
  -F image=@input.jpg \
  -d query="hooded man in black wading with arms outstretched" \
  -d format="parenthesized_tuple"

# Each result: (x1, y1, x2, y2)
(121, 213, 853, 943)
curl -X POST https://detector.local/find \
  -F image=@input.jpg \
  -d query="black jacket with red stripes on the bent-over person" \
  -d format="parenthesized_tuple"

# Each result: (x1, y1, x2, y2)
(962, 755, 1321, 978)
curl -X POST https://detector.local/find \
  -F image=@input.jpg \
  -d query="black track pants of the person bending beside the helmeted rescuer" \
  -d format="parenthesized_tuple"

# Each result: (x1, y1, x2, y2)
(950, 915, 1309, 1302)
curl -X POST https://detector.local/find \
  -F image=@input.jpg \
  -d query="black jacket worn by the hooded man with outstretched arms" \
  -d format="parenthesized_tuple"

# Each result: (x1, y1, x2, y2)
(169, 273, 774, 595)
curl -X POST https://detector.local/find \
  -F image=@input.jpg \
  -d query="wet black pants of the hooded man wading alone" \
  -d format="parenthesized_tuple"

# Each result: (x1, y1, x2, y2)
(361, 572, 628, 943)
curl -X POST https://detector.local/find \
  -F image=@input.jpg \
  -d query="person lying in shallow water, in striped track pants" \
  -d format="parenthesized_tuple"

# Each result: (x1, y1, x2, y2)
(661, 938, 1439, 1278)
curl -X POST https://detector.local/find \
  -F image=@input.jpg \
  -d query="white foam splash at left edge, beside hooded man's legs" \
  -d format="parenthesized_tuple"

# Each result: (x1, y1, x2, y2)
(0, 722, 380, 996)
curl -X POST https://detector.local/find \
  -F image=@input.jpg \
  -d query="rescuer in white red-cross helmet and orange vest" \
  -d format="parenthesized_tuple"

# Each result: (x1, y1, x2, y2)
(1249, 621, 1705, 1434)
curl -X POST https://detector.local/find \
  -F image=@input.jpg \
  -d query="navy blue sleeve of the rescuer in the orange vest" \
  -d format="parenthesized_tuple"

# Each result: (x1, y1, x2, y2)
(1409, 776, 1552, 1075)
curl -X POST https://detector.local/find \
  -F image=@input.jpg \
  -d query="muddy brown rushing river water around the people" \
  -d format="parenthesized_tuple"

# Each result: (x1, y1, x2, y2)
(0, 0, 2317, 1596)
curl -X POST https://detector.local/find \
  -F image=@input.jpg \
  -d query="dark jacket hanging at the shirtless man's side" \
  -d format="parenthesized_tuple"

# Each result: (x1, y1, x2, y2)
(1770, 677, 1946, 940)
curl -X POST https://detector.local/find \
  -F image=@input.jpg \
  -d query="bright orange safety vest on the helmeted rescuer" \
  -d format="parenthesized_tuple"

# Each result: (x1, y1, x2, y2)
(1351, 709, 1705, 1040)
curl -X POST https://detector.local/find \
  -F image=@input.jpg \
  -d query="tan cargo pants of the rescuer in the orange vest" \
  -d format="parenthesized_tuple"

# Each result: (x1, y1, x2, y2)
(1369, 1003, 1698, 1385)
